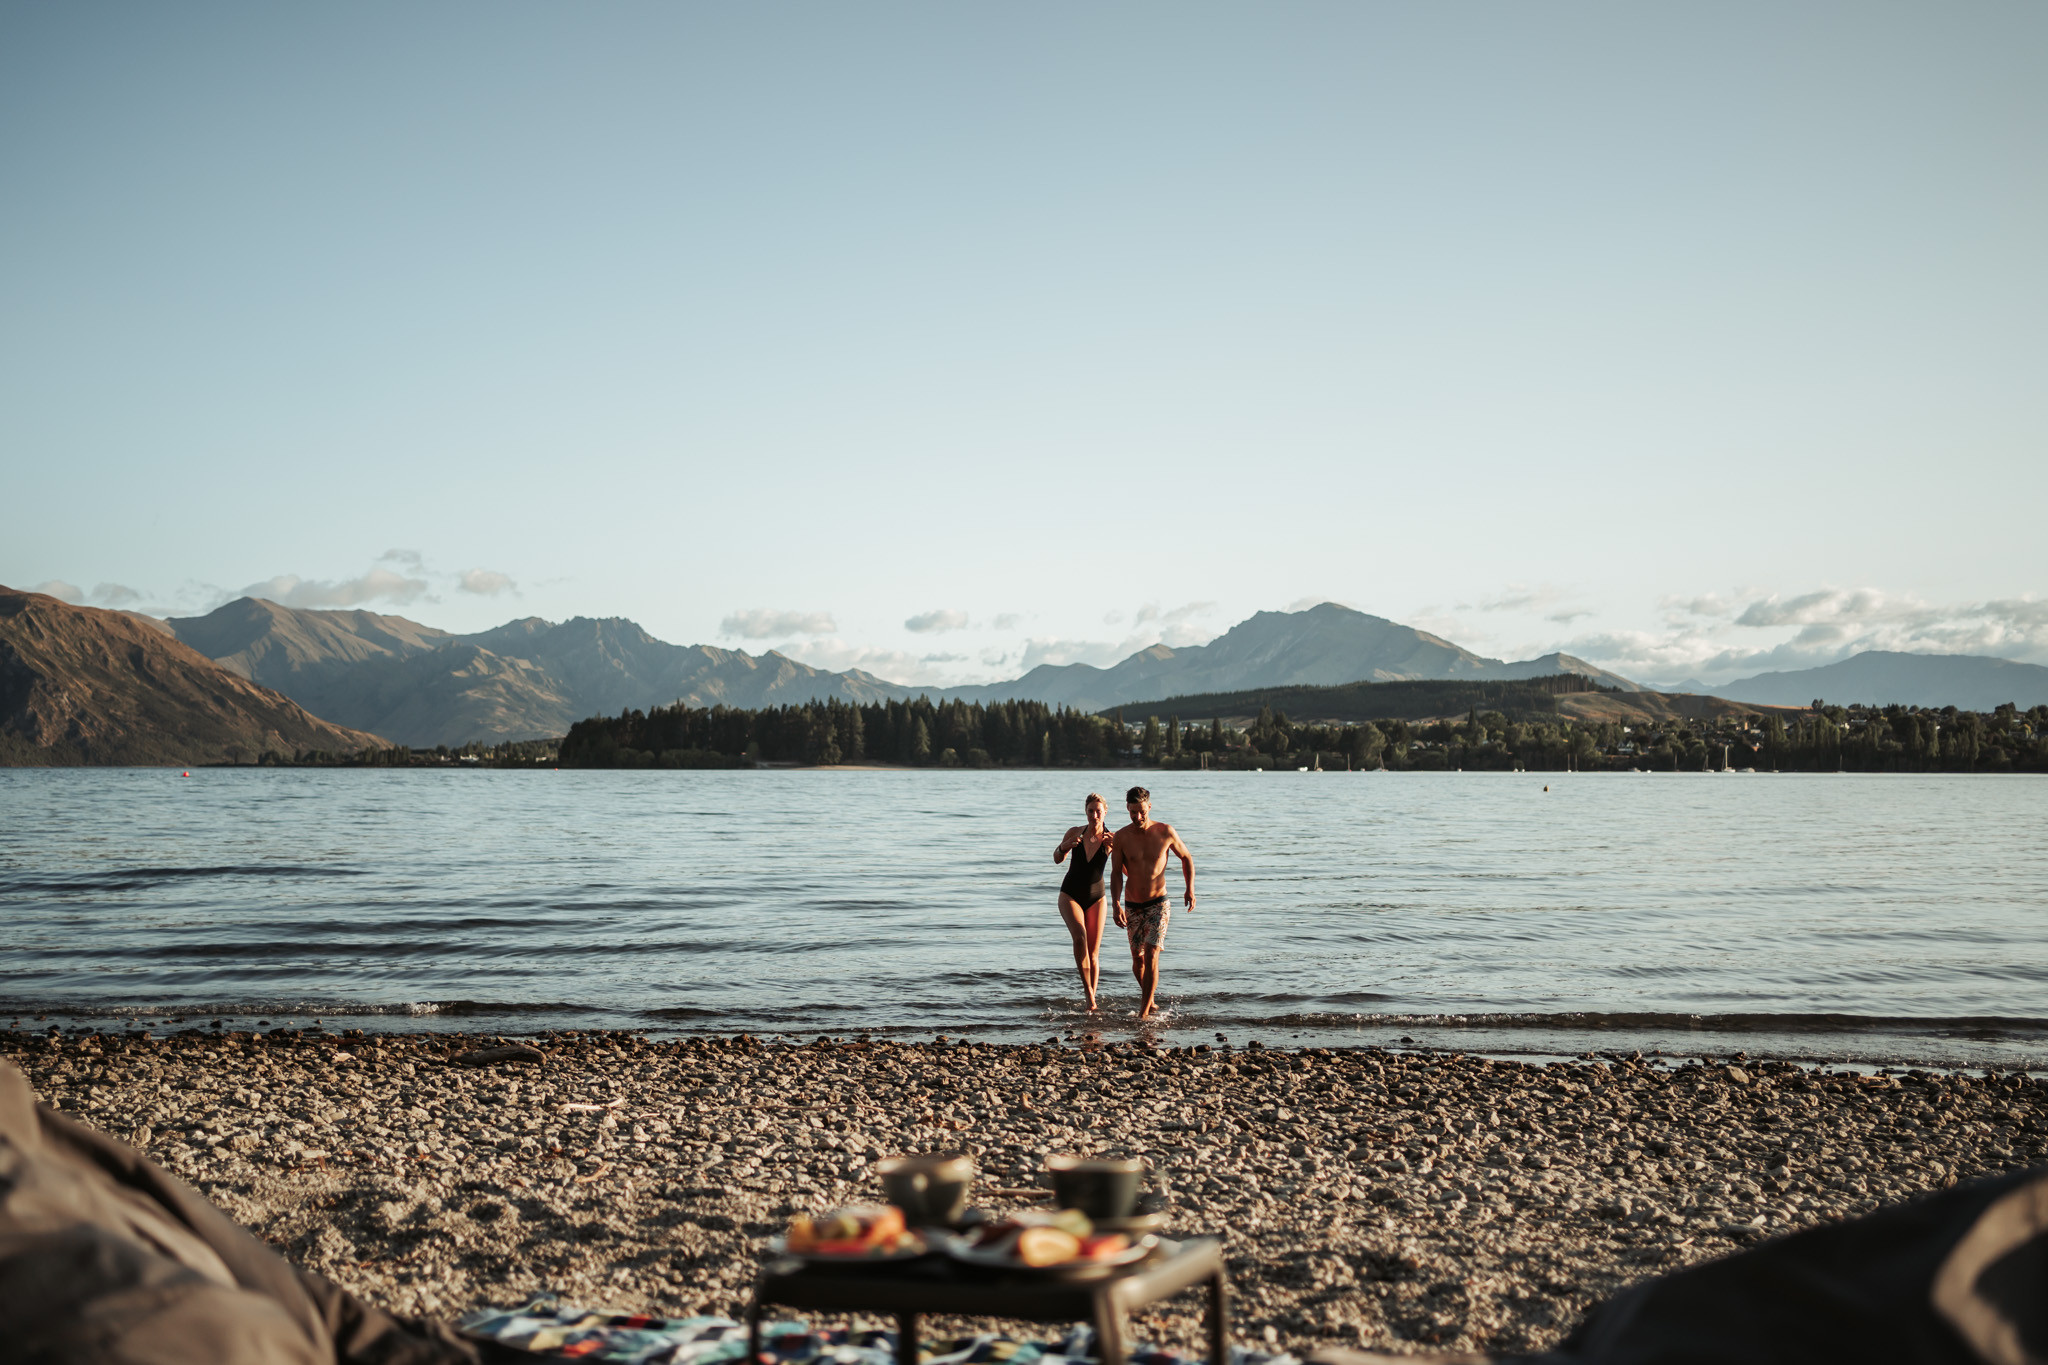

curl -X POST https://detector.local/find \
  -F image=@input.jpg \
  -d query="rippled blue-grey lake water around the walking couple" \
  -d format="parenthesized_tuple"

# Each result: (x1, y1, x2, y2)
(0, 769, 2048, 1066)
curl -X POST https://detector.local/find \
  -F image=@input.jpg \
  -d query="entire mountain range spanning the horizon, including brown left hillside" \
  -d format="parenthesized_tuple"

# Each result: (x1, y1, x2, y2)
(12, 587, 2048, 763)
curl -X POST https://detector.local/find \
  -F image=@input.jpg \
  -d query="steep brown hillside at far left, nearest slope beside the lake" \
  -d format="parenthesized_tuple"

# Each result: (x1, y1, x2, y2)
(0, 587, 383, 765)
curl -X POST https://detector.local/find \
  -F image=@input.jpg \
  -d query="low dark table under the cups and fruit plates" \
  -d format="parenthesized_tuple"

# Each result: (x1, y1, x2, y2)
(748, 1236, 1229, 1365)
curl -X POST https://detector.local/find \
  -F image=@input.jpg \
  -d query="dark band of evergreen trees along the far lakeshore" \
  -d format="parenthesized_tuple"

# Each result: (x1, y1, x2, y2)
(532, 698, 2048, 774)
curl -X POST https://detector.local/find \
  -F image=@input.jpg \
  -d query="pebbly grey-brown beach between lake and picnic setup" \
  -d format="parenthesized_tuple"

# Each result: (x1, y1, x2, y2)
(0, 1021, 2048, 1353)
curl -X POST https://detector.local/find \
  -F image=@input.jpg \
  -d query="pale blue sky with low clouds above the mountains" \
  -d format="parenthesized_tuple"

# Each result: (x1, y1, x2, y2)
(0, 0, 2048, 684)
